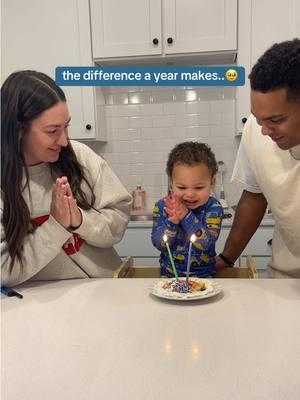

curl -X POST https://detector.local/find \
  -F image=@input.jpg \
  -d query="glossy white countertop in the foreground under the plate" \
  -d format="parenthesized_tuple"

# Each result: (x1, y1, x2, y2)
(2, 279, 300, 400)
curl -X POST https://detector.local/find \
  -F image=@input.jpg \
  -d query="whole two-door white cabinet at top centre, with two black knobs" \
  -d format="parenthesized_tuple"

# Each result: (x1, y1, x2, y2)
(90, 0, 237, 60)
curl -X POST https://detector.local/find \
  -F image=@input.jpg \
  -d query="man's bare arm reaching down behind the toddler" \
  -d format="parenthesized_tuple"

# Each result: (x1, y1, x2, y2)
(216, 190, 267, 268)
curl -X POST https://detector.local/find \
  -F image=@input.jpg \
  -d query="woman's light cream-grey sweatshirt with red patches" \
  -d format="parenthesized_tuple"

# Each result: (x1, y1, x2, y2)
(1, 141, 131, 286)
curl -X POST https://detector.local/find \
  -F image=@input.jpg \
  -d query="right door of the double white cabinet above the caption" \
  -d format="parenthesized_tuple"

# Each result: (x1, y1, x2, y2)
(163, 0, 237, 54)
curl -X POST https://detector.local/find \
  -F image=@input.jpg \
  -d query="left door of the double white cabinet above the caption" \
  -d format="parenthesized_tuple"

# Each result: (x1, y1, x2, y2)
(90, 0, 161, 59)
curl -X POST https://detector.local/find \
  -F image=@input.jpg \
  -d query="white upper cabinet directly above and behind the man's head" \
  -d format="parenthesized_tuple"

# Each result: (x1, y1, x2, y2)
(236, 0, 300, 134)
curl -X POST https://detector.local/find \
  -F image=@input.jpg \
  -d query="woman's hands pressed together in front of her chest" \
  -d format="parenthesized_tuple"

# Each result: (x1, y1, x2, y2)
(50, 176, 82, 229)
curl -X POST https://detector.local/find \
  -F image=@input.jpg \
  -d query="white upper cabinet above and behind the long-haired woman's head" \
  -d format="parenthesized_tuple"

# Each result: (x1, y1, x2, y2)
(1, 0, 104, 139)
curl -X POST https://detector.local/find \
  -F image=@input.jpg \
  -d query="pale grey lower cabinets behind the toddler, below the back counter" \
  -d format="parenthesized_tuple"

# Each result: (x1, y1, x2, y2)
(115, 222, 273, 269)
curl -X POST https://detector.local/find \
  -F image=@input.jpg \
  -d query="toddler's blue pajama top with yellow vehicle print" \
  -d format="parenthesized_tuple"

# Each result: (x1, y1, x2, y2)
(151, 196, 223, 278)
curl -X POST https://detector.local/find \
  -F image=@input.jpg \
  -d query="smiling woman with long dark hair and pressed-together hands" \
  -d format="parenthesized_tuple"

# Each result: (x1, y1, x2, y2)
(1, 71, 131, 286)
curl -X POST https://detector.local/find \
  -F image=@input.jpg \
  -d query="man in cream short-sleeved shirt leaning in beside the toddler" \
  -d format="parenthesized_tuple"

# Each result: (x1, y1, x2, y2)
(217, 39, 300, 278)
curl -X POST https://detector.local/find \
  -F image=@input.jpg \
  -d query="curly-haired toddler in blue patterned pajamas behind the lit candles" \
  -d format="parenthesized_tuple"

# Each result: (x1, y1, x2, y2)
(151, 142, 223, 278)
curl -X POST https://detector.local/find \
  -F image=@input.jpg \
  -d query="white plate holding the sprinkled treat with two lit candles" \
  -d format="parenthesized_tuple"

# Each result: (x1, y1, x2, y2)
(151, 278, 222, 301)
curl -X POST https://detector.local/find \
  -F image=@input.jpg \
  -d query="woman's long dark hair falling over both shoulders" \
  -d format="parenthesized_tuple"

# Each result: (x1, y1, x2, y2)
(1, 71, 95, 269)
